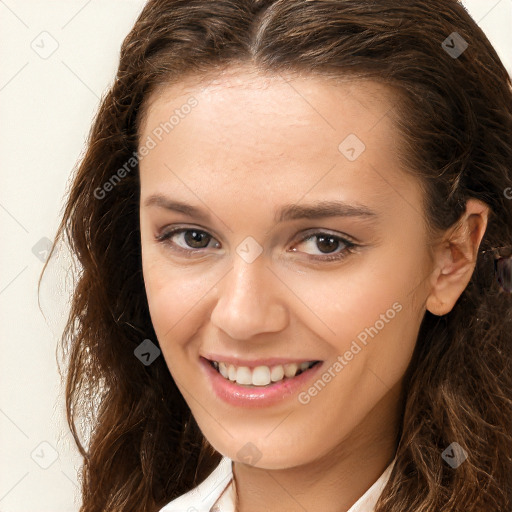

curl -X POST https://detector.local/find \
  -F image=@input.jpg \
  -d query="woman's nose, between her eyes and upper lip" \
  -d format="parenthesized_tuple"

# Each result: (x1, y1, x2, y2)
(211, 253, 288, 340)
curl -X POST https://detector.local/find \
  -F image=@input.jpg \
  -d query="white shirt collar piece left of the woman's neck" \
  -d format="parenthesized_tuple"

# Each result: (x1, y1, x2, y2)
(160, 457, 233, 512)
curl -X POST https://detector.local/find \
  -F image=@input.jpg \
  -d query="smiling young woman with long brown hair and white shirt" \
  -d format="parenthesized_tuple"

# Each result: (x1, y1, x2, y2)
(41, 0, 512, 512)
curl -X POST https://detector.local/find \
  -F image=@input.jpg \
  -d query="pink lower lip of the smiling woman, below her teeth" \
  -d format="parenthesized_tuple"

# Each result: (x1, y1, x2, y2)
(199, 357, 323, 407)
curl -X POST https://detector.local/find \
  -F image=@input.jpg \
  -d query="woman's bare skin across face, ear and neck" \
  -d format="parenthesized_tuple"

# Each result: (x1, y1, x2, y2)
(140, 67, 488, 512)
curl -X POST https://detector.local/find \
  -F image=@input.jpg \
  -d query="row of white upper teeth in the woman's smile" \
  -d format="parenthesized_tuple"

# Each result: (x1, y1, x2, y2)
(213, 361, 314, 386)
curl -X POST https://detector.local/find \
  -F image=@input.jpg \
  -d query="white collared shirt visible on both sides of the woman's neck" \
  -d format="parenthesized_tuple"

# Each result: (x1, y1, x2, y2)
(160, 457, 396, 512)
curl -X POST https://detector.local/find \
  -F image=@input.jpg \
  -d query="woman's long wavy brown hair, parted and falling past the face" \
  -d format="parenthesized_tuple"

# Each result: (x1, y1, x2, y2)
(43, 0, 512, 512)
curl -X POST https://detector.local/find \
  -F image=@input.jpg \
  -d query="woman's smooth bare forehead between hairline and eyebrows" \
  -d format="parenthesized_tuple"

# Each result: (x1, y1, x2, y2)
(140, 68, 419, 220)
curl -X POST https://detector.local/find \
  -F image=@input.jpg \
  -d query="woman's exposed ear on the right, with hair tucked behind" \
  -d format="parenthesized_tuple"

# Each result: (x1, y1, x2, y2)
(426, 198, 489, 316)
